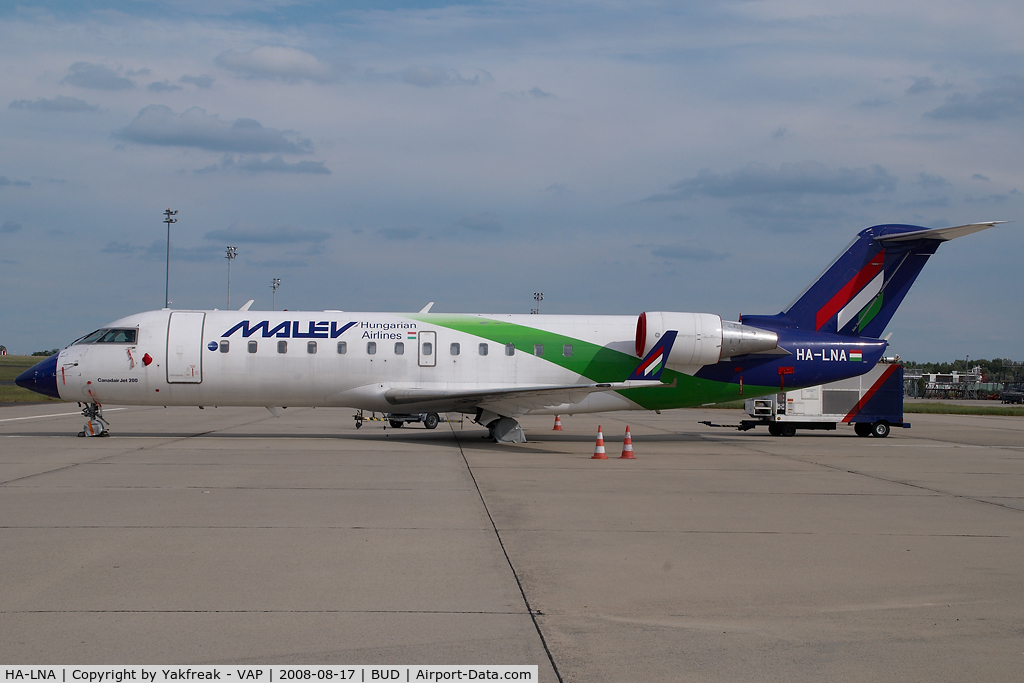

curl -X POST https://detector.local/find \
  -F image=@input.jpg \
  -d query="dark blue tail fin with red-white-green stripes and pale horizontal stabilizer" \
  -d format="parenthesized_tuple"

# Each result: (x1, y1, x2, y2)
(740, 221, 999, 338)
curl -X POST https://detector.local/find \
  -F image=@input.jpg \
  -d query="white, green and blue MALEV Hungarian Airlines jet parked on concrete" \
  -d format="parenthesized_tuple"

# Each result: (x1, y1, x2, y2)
(15, 221, 1004, 442)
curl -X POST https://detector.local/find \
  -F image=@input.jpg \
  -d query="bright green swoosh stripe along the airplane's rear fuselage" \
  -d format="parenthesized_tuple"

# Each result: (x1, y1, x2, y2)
(407, 313, 778, 411)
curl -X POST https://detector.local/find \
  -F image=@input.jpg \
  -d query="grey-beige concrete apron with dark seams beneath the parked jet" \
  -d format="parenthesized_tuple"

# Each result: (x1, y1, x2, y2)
(0, 403, 1024, 682)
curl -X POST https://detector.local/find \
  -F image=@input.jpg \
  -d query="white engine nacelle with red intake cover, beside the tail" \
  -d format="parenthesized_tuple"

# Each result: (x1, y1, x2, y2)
(636, 311, 778, 366)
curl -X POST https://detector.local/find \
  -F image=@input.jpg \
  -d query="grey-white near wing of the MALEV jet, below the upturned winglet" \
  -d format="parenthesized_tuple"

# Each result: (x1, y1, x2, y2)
(384, 380, 671, 410)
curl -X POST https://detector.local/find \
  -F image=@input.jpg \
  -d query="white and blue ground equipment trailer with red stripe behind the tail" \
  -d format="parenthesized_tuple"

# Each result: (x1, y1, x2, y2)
(739, 358, 910, 437)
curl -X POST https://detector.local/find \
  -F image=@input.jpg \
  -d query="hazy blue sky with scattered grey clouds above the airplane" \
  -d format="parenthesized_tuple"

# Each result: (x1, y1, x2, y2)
(0, 0, 1024, 360)
